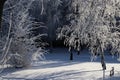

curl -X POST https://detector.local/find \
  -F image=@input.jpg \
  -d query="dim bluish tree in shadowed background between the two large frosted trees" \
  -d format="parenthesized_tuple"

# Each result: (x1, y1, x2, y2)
(46, 0, 62, 51)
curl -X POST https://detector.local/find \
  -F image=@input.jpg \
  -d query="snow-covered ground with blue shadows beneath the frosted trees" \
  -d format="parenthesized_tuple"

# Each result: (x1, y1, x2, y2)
(0, 48, 120, 80)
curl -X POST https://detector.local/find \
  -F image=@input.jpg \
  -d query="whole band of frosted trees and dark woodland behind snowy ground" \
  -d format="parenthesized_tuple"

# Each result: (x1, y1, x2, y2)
(0, 0, 120, 70)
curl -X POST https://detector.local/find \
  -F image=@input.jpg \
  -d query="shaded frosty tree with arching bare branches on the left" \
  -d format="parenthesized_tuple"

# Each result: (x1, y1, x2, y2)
(1, 0, 44, 67)
